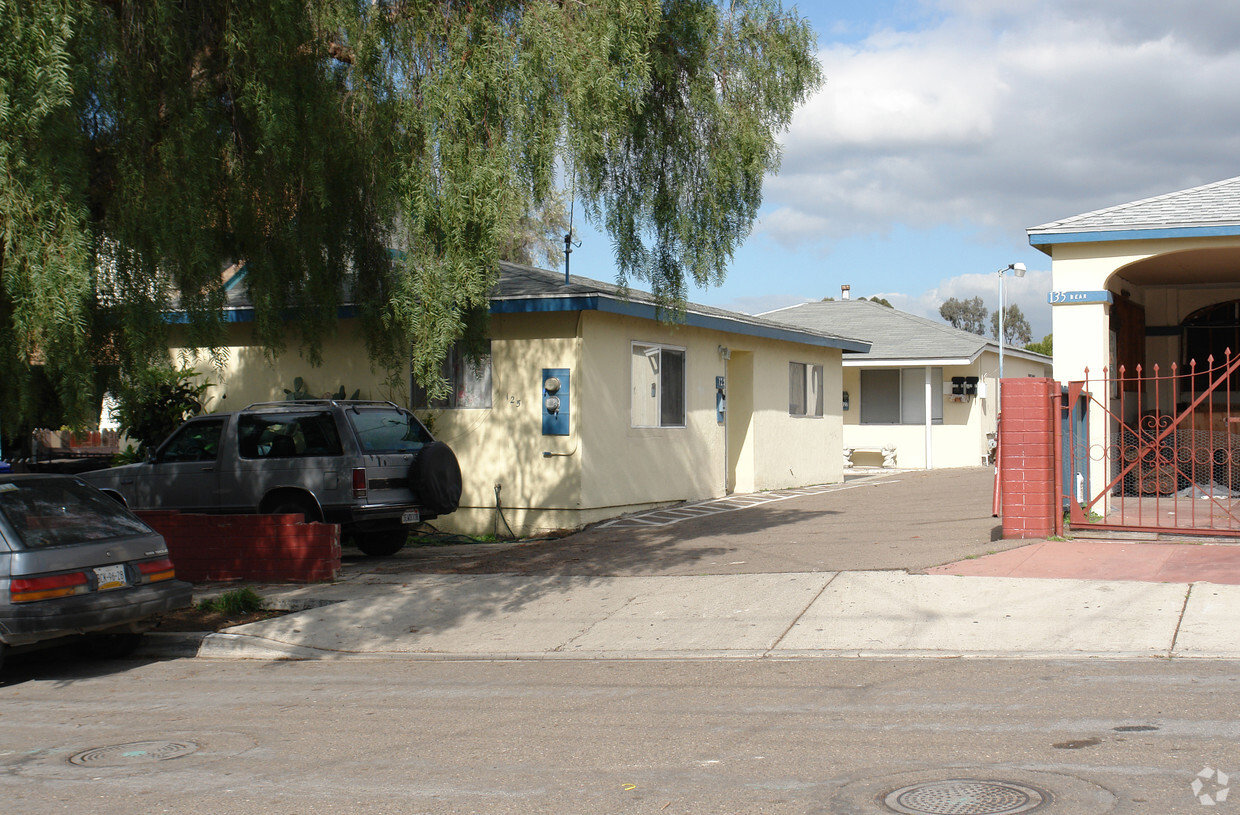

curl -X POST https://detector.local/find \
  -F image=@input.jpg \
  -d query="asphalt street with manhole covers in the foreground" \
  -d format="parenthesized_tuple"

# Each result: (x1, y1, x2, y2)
(0, 655, 1240, 815)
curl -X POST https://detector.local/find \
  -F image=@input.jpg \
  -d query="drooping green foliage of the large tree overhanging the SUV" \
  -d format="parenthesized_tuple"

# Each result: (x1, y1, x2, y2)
(0, 0, 821, 429)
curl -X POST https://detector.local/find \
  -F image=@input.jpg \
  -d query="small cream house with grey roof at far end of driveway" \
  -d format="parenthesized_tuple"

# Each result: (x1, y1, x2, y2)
(763, 300, 1050, 469)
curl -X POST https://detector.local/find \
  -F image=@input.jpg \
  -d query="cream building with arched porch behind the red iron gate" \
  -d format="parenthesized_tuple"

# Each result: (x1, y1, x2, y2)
(1028, 177, 1240, 515)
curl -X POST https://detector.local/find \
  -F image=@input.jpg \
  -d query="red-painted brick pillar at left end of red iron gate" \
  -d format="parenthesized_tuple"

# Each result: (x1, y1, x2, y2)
(999, 378, 1060, 538)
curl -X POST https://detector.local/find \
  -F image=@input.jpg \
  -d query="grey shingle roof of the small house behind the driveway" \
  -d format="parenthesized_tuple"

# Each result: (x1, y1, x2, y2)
(761, 300, 1047, 363)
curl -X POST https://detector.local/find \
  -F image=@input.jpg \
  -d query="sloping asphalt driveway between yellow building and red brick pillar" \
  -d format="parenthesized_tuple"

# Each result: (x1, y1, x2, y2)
(386, 468, 1022, 577)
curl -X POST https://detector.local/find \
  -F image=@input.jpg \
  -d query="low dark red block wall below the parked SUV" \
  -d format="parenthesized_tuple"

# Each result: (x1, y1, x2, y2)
(135, 511, 340, 583)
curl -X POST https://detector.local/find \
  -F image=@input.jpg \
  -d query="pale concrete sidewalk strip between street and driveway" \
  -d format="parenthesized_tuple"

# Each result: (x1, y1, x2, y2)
(144, 572, 1240, 660)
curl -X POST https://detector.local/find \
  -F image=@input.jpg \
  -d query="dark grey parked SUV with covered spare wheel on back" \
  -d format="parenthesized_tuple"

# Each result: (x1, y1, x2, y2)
(82, 399, 461, 554)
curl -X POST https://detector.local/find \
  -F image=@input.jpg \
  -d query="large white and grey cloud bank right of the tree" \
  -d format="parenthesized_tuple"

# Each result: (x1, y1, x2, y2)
(758, 0, 1240, 246)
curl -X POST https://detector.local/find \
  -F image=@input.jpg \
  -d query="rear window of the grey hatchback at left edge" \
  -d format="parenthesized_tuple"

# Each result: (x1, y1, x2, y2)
(0, 478, 154, 548)
